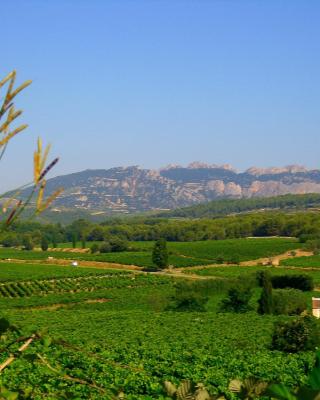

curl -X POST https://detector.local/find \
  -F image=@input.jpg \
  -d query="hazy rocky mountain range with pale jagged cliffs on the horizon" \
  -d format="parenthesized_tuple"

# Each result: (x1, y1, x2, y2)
(16, 162, 320, 213)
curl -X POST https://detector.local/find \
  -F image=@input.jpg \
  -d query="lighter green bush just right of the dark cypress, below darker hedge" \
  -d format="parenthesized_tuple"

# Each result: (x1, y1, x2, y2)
(273, 289, 307, 315)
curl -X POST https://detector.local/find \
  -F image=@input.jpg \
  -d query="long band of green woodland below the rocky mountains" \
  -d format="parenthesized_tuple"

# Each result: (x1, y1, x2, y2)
(0, 212, 320, 246)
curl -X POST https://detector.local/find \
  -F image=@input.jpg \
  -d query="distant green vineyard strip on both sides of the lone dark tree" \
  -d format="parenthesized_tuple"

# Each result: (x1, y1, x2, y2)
(0, 238, 301, 267)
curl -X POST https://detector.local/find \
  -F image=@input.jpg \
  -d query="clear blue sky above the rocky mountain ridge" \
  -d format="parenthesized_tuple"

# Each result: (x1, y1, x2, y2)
(0, 0, 320, 191)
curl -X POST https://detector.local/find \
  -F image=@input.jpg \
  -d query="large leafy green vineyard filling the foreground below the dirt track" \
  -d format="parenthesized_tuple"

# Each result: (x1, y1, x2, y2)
(0, 263, 320, 400)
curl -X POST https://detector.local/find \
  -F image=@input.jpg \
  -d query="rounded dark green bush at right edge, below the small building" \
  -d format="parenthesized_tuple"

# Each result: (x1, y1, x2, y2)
(271, 315, 320, 353)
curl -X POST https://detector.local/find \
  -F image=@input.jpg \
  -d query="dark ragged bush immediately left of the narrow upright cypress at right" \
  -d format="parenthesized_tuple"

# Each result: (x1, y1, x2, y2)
(220, 286, 252, 313)
